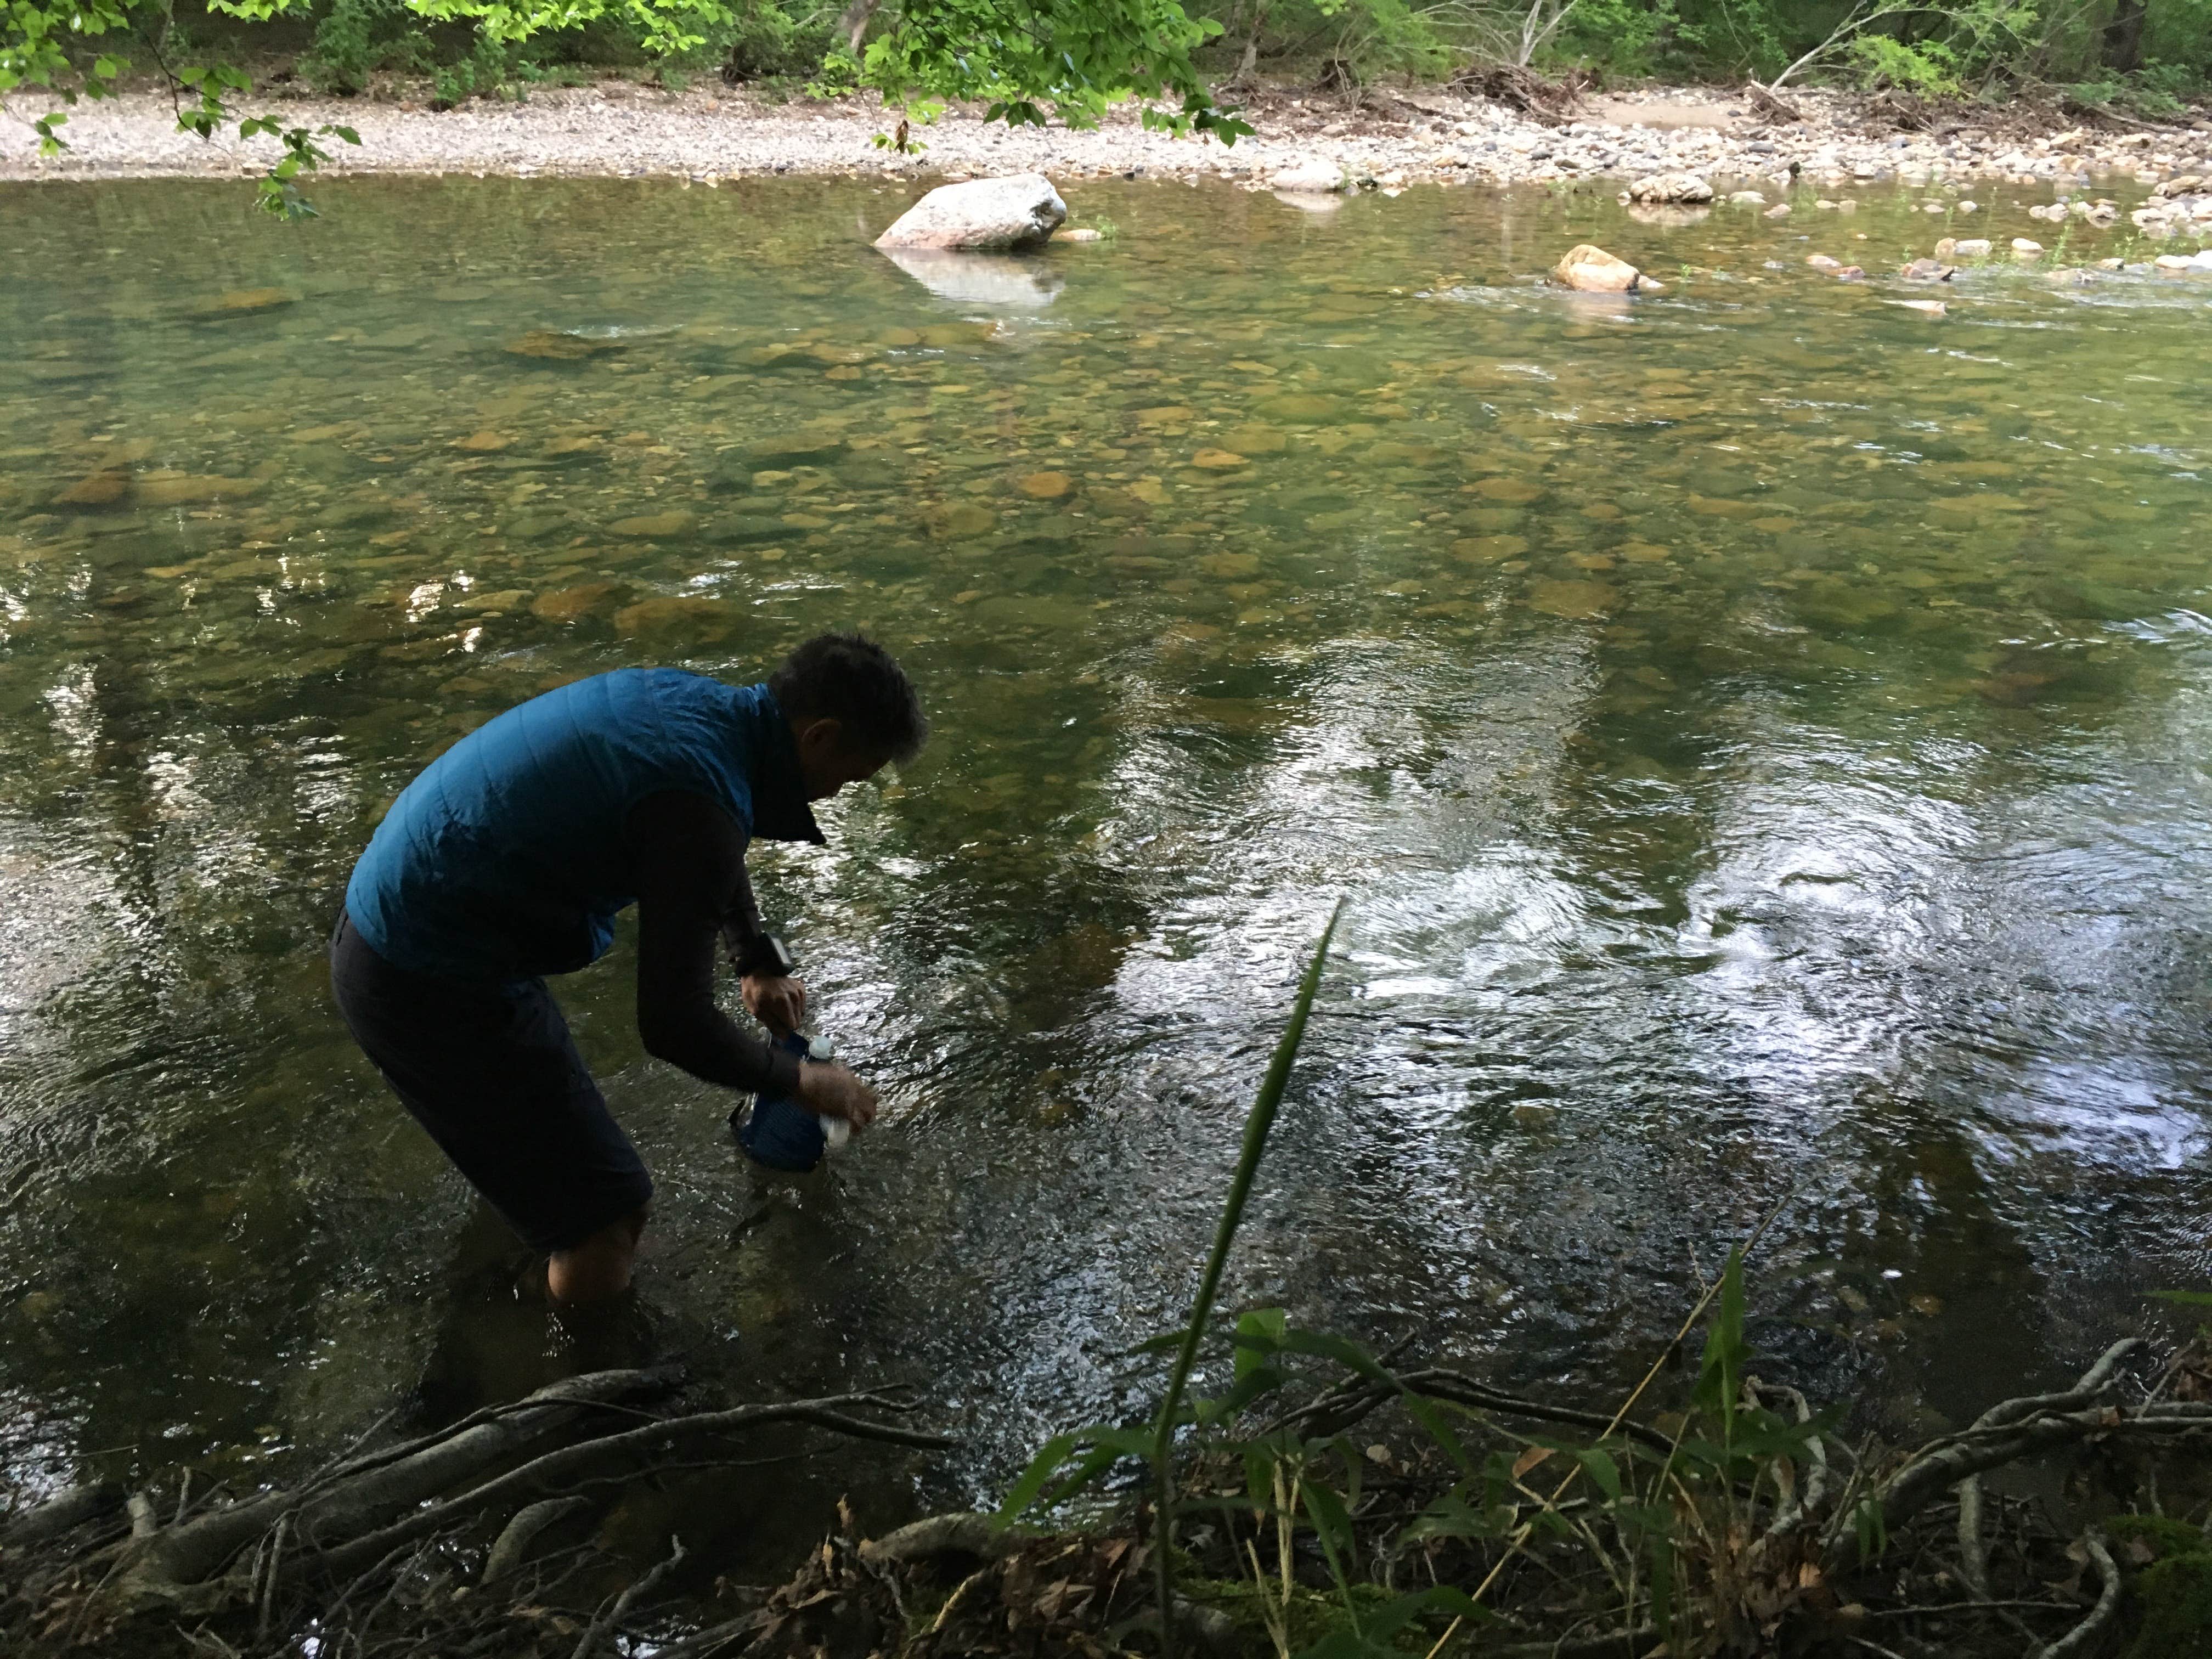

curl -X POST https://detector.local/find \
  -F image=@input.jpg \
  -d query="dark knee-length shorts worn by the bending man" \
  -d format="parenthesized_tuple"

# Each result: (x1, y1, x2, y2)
(330, 916, 652, 1250)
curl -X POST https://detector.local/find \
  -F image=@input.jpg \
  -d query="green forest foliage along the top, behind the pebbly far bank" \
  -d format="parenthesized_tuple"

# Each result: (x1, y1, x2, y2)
(0, 0, 2212, 151)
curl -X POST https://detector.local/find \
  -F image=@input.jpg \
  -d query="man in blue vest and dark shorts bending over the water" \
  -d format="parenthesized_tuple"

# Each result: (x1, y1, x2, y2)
(330, 635, 929, 1303)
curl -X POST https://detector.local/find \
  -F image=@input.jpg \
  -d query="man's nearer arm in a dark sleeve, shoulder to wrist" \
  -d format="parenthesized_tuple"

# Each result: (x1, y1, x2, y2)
(626, 789, 799, 1095)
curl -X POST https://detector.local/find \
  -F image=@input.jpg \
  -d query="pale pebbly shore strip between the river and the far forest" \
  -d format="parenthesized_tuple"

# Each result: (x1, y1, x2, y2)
(0, 80, 2212, 195)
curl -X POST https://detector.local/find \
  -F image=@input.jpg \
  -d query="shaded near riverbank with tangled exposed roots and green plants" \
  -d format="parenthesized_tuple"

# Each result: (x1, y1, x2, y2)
(0, 1338, 2212, 1659)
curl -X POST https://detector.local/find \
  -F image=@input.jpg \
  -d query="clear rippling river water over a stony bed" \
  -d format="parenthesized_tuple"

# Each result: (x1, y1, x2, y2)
(0, 177, 2212, 1531)
